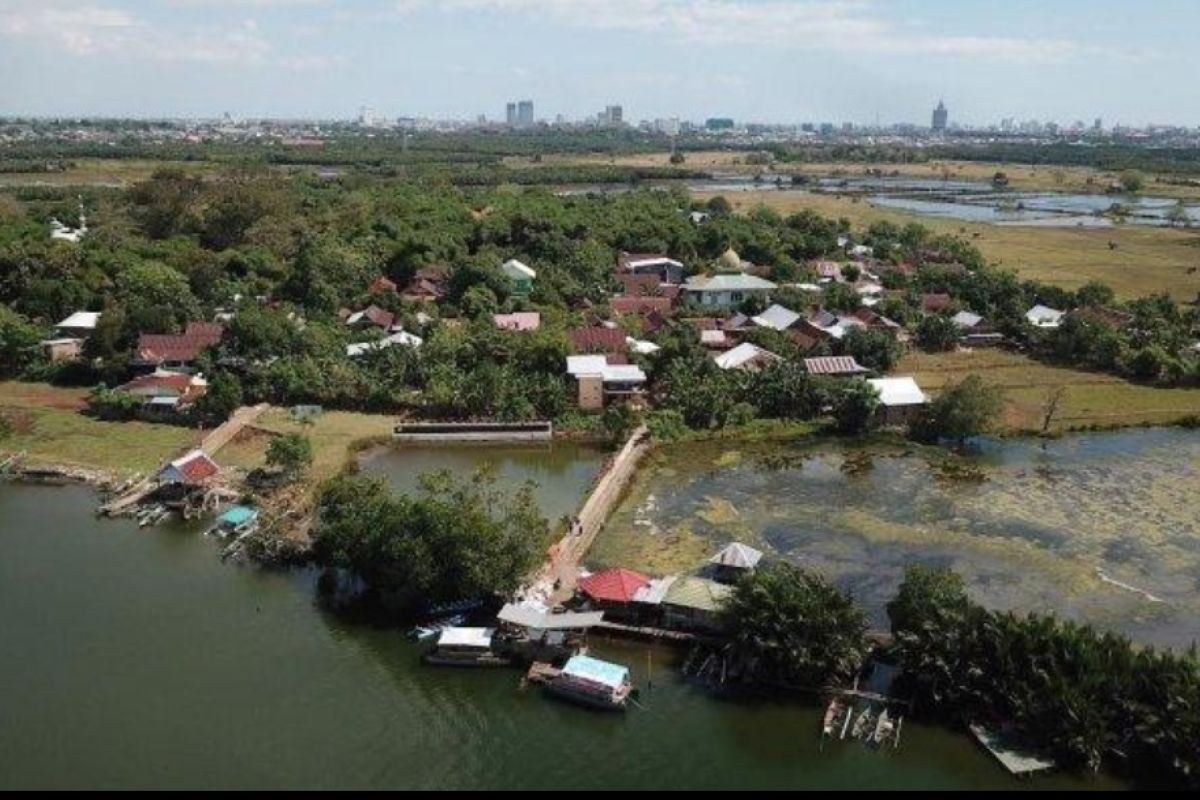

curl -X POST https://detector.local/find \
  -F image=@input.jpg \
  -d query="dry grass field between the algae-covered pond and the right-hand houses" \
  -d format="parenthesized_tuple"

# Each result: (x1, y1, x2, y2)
(894, 350, 1200, 432)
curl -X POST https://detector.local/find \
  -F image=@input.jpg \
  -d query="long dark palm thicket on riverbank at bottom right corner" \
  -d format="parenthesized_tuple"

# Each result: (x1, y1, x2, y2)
(888, 566, 1200, 781)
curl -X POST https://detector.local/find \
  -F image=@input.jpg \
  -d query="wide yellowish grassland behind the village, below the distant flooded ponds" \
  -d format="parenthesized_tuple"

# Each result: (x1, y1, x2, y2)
(696, 190, 1200, 302)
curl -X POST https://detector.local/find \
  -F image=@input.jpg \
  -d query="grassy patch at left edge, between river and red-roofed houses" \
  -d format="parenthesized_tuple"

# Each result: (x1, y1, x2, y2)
(0, 381, 202, 475)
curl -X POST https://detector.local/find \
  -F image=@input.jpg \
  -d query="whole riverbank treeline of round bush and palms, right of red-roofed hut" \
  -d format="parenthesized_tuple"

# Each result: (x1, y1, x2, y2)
(725, 563, 1200, 784)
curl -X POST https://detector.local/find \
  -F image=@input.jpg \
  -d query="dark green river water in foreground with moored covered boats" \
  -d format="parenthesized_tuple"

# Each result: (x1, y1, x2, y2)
(0, 441, 1142, 789)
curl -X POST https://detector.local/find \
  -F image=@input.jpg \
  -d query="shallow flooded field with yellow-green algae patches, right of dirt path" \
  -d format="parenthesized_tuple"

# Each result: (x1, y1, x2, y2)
(592, 428, 1200, 645)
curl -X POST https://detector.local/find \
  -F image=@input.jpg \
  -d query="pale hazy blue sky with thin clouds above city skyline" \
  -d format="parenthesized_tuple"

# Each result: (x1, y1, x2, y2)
(0, 0, 1200, 125)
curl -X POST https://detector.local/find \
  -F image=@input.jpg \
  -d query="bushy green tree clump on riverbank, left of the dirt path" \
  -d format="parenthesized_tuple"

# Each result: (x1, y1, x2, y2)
(313, 473, 550, 608)
